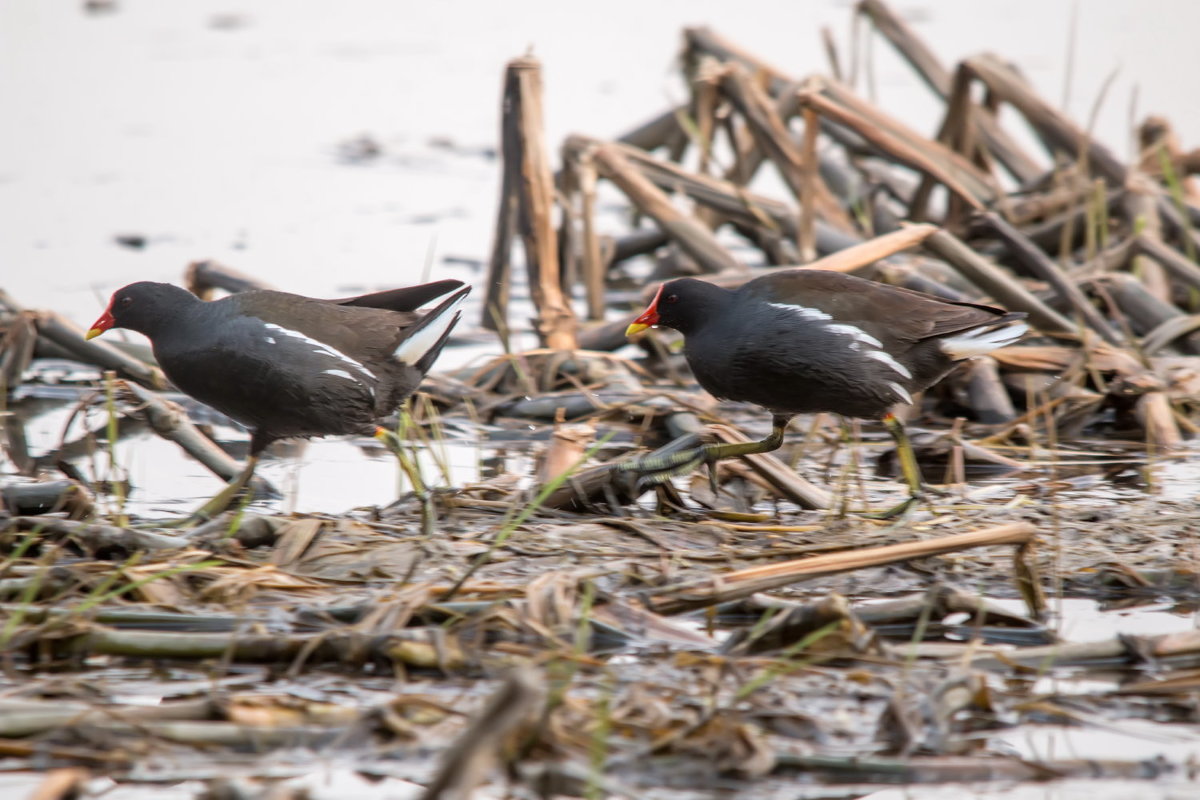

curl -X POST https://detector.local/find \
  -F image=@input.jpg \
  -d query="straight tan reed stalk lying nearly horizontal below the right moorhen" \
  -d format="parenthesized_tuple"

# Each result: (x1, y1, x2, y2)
(646, 522, 1037, 614)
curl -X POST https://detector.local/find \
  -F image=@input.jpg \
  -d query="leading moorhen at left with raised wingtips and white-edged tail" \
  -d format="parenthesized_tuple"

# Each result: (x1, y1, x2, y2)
(86, 281, 470, 516)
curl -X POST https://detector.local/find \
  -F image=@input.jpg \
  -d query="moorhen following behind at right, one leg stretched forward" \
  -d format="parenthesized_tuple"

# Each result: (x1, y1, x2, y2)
(623, 269, 1027, 517)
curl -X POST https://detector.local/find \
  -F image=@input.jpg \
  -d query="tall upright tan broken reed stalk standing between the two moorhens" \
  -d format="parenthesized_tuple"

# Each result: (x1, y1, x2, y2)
(500, 56, 577, 350)
